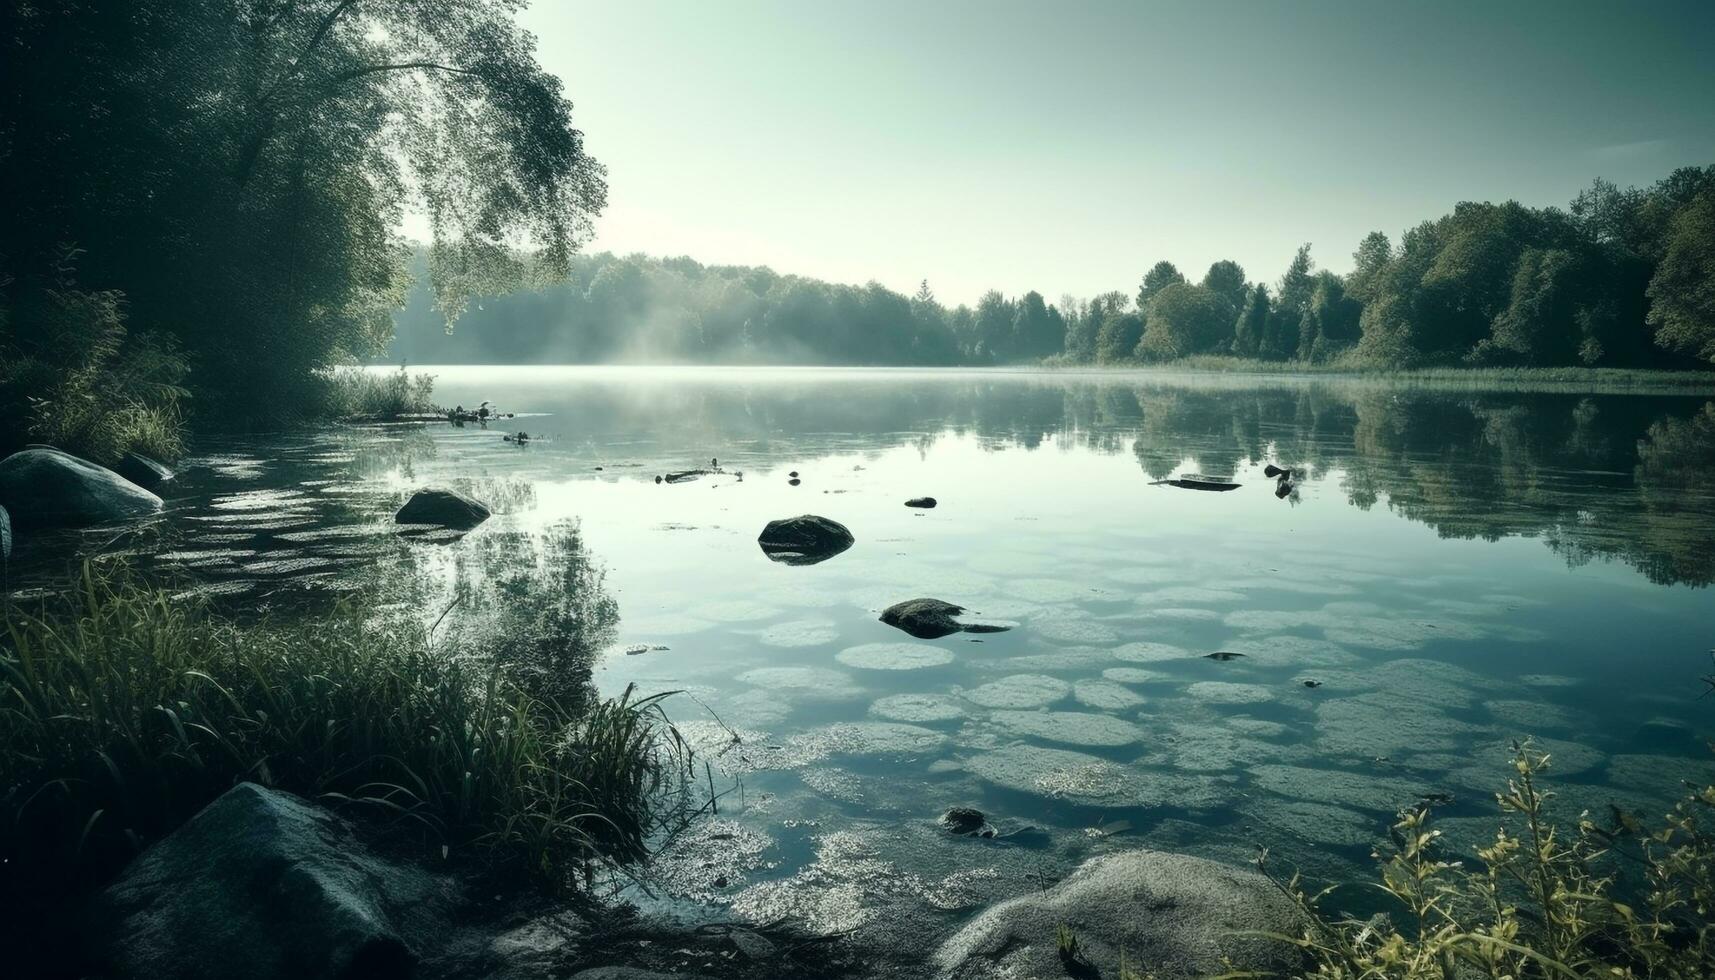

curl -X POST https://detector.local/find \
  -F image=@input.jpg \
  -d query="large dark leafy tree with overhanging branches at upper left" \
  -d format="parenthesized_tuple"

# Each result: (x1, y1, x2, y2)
(0, 0, 605, 424)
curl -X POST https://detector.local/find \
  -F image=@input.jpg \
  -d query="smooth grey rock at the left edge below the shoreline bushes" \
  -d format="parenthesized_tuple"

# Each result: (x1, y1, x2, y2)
(0, 448, 161, 529)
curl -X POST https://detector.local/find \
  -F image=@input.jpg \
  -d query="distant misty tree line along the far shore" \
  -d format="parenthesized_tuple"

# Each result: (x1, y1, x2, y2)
(389, 166, 1715, 369)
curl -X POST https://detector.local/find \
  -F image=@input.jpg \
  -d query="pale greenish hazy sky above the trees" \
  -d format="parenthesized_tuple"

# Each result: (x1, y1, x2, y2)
(523, 0, 1715, 304)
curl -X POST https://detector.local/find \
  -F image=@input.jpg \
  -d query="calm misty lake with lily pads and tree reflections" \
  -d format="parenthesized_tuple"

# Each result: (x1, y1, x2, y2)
(22, 367, 1715, 941)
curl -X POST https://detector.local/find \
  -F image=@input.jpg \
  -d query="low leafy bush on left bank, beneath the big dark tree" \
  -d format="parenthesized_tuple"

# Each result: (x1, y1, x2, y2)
(0, 271, 187, 463)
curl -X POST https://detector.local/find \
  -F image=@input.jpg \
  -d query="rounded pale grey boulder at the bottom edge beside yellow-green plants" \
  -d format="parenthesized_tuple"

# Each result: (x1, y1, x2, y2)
(935, 851, 1303, 980)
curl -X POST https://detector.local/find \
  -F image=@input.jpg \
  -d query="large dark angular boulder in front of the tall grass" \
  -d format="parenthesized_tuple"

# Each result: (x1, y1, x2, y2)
(93, 783, 446, 980)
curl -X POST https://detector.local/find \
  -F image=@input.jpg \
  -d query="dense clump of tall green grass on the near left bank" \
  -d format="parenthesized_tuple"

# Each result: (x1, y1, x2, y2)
(0, 568, 696, 904)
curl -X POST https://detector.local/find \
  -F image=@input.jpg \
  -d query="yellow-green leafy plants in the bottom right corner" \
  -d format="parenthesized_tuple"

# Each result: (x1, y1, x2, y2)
(1259, 741, 1715, 980)
